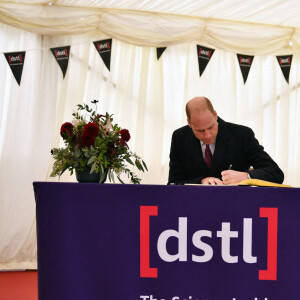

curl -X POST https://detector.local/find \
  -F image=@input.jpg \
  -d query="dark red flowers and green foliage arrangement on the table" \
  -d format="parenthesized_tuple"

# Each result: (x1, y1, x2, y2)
(50, 100, 147, 184)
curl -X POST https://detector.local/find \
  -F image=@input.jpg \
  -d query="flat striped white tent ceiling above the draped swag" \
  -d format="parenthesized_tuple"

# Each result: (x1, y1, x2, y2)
(12, 0, 300, 28)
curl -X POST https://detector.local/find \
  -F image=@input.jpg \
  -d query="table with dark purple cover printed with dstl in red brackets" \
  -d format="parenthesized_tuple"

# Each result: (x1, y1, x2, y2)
(33, 182, 300, 300)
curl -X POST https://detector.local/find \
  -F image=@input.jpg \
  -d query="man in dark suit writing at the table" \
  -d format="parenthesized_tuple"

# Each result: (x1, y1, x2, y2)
(169, 97, 284, 185)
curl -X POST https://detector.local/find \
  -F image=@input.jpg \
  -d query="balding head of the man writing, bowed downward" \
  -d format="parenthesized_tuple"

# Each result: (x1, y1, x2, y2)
(185, 97, 218, 145)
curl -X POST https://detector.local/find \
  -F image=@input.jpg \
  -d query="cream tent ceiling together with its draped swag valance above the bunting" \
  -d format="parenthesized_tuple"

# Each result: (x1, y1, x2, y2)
(0, 0, 300, 54)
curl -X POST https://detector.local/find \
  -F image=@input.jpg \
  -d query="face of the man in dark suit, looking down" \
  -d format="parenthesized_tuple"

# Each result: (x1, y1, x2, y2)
(188, 109, 218, 145)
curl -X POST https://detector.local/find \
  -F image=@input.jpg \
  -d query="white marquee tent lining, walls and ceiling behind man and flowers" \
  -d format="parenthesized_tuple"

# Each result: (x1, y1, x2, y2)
(0, 0, 300, 269)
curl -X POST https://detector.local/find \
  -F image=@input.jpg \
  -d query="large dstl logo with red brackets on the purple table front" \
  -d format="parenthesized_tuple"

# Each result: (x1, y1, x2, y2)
(140, 206, 278, 280)
